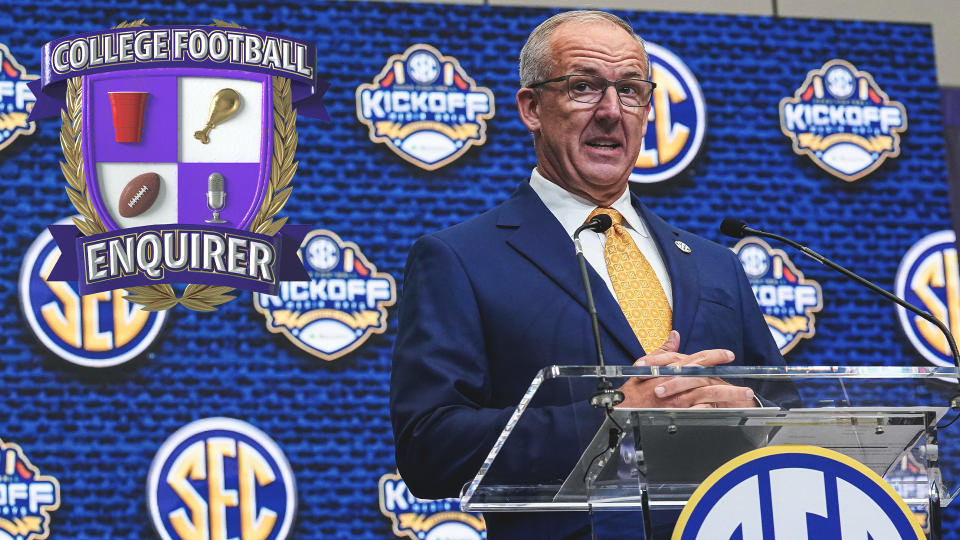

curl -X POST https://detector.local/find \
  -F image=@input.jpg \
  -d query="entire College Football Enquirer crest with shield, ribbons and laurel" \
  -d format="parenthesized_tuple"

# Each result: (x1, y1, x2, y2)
(33, 21, 326, 311)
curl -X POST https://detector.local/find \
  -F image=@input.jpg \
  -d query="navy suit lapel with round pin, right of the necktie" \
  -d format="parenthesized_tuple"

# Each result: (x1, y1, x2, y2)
(633, 195, 700, 352)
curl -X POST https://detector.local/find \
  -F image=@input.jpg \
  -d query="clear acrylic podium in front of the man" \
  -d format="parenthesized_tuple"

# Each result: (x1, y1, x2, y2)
(461, 366, 960, 539)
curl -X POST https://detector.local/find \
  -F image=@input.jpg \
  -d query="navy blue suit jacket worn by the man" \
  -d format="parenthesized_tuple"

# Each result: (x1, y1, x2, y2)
(390, 183, 796, 538)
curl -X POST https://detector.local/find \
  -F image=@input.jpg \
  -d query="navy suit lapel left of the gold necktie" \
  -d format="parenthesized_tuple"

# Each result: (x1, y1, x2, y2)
(497, 183, 643, 363)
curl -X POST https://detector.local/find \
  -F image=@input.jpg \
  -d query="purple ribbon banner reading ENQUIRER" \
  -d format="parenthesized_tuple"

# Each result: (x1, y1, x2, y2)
(47, 224, 310, 295)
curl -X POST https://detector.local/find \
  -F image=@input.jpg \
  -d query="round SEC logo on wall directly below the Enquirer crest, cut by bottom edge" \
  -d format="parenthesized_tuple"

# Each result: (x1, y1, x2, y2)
(147, 418, 297, 540)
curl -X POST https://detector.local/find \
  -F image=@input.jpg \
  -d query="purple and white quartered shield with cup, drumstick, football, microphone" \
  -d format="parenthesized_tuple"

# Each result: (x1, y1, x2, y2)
(82, 69, 273, 231)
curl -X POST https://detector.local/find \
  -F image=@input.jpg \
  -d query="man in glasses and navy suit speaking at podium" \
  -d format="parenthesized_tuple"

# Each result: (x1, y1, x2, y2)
(390, 11, 796, 539)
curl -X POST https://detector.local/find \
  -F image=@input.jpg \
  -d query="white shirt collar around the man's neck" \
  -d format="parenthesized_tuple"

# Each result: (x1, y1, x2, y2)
(530, 169, 649, 238)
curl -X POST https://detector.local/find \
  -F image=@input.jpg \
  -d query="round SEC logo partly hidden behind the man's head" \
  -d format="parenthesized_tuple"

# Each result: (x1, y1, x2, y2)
(630, 42, 707, 184)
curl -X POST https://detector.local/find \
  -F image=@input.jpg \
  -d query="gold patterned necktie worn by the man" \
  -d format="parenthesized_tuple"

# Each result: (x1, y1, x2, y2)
(587, 208, 673, 352)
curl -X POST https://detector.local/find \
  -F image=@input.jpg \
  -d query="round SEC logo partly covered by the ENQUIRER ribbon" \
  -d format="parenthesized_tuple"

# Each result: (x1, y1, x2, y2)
(19, 219, 167, 368)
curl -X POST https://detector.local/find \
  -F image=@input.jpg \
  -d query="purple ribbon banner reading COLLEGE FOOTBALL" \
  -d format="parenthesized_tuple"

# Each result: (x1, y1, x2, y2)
(27, 26, 330, 121)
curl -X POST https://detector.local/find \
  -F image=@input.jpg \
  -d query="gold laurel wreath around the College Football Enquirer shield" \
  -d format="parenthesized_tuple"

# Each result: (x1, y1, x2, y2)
(60, 19, 299, 311)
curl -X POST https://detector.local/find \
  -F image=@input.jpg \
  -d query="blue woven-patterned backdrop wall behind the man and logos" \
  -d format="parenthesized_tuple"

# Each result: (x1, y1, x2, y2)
(0, 0, 948, 539)
